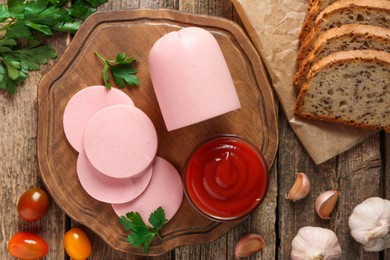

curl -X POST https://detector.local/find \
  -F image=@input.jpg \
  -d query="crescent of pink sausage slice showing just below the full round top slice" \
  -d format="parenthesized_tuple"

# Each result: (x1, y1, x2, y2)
(77, 150, 153, 203)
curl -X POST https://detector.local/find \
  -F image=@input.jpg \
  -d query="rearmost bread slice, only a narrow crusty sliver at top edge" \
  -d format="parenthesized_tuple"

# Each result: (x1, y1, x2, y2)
(299, 0, 338, 43)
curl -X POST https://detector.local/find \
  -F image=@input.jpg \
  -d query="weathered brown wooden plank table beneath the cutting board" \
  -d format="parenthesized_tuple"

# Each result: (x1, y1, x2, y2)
(0, 0, 390, 260)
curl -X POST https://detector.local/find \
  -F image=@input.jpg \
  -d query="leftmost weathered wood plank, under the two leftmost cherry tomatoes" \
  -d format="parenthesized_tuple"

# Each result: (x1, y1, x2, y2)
(0, 34, 68, 259)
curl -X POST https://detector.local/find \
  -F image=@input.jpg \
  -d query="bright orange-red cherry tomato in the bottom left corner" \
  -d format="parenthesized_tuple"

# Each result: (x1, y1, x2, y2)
(8, 232, 49, 260)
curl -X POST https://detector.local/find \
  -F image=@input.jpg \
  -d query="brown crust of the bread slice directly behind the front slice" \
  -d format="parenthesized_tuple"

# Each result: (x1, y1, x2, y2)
(294, 24, 390, 88)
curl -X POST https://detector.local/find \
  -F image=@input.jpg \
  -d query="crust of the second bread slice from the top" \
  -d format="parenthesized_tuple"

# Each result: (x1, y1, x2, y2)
(297, 0, 390, 66)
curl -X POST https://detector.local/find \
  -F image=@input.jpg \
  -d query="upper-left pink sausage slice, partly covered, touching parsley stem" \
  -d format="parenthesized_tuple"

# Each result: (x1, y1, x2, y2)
(63, 86, 134, 152)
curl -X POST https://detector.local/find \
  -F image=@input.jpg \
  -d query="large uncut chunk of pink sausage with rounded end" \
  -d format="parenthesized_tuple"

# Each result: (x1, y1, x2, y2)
(149, 27, 240, 131)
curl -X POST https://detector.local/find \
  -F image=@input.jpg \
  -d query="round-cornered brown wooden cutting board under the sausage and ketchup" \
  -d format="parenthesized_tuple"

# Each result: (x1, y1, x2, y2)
(37, 9, 278, 255)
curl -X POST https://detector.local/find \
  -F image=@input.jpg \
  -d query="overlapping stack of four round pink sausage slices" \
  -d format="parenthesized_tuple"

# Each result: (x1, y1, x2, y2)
(63, 86, 183, 223)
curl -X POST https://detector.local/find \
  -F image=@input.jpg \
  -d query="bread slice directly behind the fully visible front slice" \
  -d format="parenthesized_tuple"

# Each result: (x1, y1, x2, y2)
(294, 24, 390, 88)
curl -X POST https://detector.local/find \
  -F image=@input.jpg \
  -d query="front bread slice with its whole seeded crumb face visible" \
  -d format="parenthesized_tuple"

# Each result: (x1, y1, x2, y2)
(295, 50, 390, 132)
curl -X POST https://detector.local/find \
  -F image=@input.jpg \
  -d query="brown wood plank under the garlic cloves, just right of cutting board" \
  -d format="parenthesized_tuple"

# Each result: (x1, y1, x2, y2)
(278, 115, 337, 259)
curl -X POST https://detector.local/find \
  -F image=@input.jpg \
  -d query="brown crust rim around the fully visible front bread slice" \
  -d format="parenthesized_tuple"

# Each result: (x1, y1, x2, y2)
(294, 50, 390, 132)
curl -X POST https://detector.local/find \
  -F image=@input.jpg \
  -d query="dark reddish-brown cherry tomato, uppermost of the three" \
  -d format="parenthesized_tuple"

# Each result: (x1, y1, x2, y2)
(18, 188, 49, 222)
